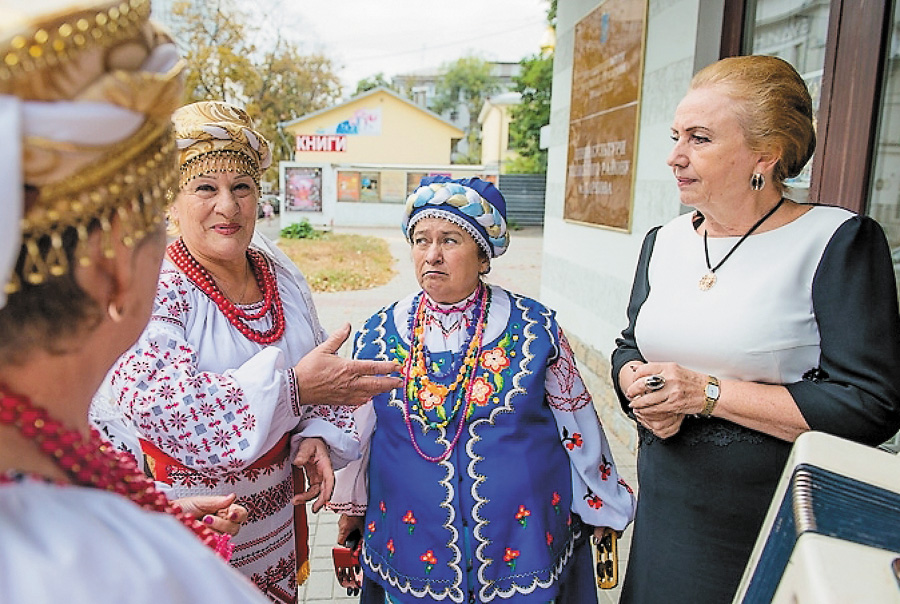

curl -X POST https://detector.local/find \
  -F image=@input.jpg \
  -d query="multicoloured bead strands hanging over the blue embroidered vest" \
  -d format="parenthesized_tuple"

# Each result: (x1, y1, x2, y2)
(403, 283, 491, 463)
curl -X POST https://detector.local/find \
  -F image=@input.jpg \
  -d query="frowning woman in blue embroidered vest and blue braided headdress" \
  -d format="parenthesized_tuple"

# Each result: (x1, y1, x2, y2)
(331, 177, 634, 603)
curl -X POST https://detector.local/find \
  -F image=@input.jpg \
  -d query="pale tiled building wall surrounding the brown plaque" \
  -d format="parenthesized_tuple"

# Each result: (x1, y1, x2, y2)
(541, 0, 724, 443)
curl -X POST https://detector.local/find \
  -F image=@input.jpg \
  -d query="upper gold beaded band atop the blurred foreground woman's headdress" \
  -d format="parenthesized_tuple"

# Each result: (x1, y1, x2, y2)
(0, 0, 150, 82)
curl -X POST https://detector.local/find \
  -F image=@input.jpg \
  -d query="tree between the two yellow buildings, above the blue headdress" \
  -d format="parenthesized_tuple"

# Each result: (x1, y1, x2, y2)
(431, 56, 500, 164)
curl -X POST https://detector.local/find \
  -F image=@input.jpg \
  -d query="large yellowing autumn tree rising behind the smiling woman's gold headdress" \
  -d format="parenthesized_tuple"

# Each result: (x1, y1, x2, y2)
(172, 0, 341, 180)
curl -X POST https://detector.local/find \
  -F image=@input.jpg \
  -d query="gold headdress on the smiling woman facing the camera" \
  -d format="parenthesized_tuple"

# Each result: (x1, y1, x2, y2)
(172, 101, 272, 188)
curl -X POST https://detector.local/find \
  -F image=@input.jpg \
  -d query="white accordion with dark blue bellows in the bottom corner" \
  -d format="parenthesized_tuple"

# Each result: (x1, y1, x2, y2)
(734, 432, 900, 604)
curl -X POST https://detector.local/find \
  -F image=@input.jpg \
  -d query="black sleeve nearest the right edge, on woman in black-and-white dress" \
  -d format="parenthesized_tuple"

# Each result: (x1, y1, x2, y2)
(786, 216, 900, 445)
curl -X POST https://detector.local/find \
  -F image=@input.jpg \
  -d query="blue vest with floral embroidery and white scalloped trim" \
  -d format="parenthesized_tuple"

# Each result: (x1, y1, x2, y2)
(355, 296, 579, 602)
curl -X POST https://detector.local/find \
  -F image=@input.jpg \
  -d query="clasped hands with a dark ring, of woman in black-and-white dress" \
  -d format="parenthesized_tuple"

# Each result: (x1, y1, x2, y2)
(622, 363, 706, 438)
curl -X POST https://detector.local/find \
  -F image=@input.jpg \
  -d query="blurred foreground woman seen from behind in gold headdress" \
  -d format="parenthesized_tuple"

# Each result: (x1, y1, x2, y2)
(0, 0, 266, 604)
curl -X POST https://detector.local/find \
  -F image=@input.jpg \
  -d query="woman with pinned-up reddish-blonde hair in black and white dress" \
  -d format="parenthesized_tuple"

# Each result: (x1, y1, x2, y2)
(612, 56, 900, 603)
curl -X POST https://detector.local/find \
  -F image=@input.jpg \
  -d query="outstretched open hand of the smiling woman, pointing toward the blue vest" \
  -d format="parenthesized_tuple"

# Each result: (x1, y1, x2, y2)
(294, 323, 403, 405)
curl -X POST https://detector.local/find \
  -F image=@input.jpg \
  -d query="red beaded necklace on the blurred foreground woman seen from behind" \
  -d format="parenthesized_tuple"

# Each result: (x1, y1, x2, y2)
(0, 388, 234, 560)
